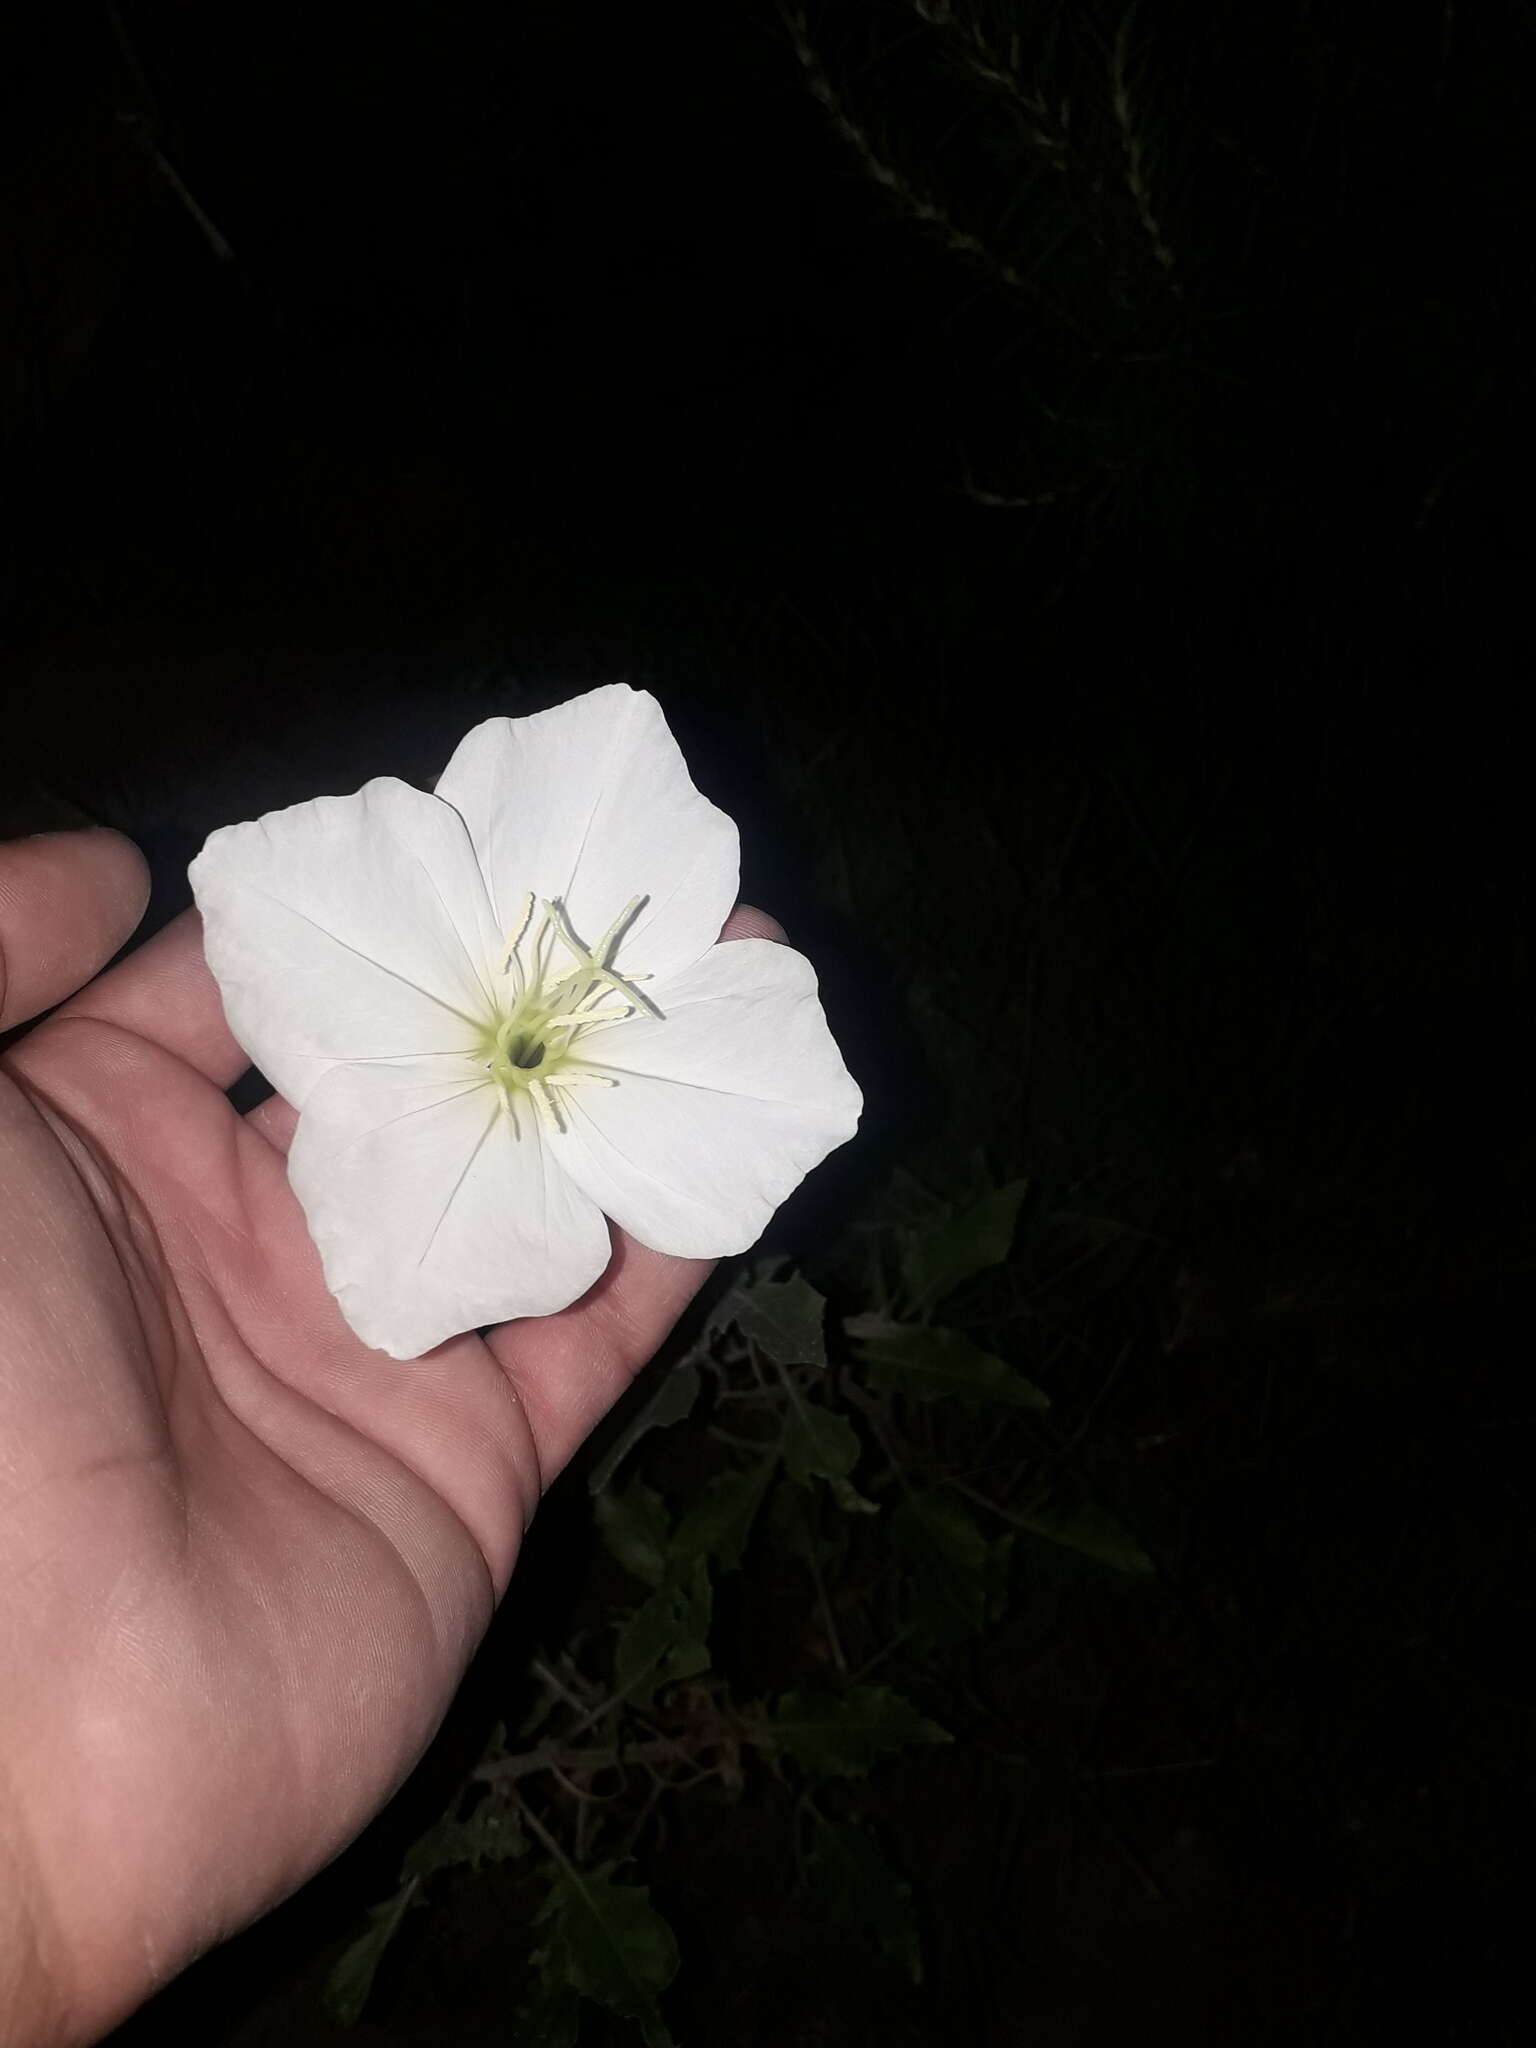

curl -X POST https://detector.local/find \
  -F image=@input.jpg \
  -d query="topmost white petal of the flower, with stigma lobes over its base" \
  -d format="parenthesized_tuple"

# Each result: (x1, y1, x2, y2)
(436, 684, 739, 977)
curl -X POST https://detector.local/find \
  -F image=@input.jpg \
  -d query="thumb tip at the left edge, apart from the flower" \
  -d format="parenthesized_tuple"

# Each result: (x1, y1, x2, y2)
(0, 827, 150, 1030)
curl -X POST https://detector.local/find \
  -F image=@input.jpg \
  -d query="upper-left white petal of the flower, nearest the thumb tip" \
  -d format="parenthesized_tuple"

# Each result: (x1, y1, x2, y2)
(190, 776, 498, 1108)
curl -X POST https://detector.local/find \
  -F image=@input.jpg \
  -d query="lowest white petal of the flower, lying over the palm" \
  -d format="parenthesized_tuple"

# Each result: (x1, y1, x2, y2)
(289, 1059, 612, 1358)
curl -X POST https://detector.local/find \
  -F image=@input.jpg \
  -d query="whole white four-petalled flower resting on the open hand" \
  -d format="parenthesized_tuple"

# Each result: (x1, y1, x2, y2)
(190, 684, 860, 1358)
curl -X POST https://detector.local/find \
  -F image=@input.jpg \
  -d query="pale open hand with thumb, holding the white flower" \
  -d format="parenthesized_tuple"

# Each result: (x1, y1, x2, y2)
(0, 831, 782, 2048)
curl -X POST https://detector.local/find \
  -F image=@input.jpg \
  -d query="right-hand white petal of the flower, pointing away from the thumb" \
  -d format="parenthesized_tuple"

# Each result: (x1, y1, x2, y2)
(551, 938, 862, 1257)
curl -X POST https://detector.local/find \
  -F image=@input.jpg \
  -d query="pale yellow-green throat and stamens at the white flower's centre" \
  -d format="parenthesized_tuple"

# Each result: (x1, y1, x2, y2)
(475, 893, 662, 1137)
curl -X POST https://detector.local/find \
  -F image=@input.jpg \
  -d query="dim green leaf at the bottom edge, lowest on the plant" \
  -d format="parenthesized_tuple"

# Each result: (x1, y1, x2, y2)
(535, 1864, 678, 2044)
